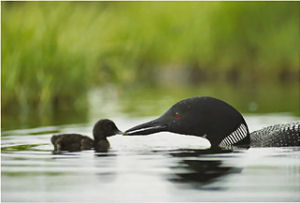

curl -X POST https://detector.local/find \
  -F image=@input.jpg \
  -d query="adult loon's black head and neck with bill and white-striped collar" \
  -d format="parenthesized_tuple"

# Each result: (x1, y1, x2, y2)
(124, 97, 250, 147)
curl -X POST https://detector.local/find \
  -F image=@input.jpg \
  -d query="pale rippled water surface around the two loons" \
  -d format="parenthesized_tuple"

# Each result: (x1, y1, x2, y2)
(1, 114, 300, 202)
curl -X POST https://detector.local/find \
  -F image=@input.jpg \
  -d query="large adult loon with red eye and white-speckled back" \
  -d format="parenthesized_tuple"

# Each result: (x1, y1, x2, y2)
(124, 97, 300, 149)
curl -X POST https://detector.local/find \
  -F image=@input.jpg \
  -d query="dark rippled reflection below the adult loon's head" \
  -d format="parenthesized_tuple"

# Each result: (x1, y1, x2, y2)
(168, 149, 242, 190)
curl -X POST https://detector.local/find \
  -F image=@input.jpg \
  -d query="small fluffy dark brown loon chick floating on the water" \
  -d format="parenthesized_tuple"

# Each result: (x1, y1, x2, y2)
(51, 119, 122, 153)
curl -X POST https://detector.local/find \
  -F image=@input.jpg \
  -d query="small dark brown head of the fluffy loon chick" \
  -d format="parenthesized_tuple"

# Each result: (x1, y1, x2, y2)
(93, 119, 122, 140)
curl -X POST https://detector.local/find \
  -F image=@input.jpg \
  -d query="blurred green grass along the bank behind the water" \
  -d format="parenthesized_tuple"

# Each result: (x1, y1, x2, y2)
(1, 2, 300, 119)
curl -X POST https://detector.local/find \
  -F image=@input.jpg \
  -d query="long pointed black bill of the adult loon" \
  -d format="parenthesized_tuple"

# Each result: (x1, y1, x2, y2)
(123, 119, 167, 135)
